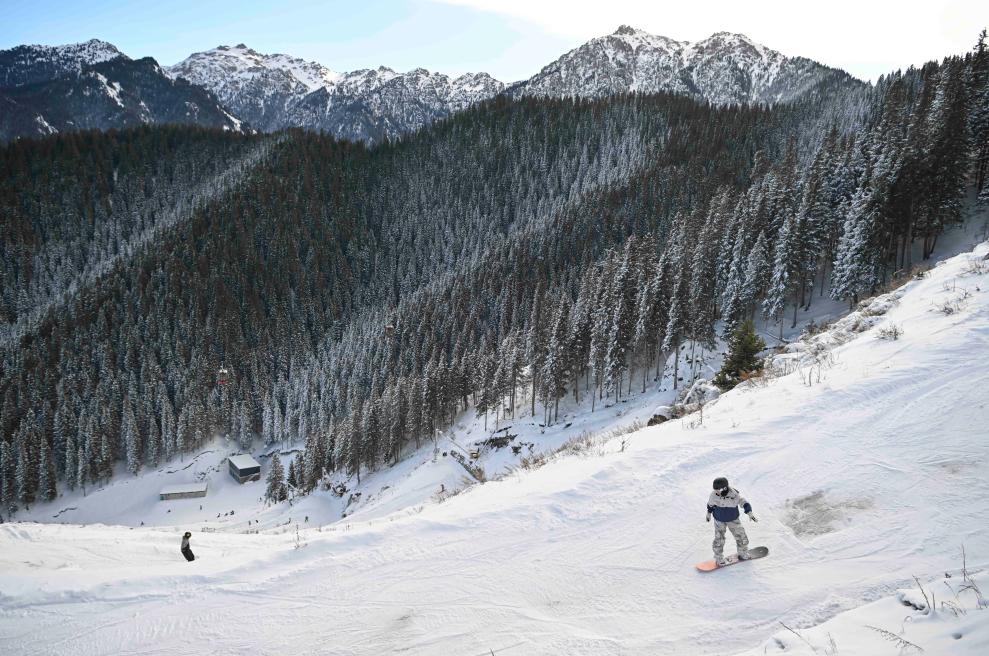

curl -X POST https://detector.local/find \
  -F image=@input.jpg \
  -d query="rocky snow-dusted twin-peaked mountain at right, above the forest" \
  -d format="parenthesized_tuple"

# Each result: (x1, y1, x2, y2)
(512, 25, 859, 104)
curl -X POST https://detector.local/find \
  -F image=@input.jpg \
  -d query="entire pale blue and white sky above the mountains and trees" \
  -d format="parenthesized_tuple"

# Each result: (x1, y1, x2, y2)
(0, 0, 989, 82)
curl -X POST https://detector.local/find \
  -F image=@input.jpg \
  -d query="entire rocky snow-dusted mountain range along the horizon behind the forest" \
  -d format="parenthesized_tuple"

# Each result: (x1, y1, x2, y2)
(0, 25, 864, 142)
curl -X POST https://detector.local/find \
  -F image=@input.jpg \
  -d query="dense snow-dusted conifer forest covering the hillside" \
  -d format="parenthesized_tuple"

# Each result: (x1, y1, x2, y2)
(0, 33, 989, 515)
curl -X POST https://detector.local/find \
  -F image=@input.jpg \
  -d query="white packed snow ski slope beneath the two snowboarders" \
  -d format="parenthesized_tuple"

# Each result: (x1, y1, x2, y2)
(0, 237, 989, 656)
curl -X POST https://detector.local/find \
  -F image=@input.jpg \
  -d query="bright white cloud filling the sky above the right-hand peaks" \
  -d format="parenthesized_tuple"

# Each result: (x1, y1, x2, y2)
(434, 0, 989, 79)
